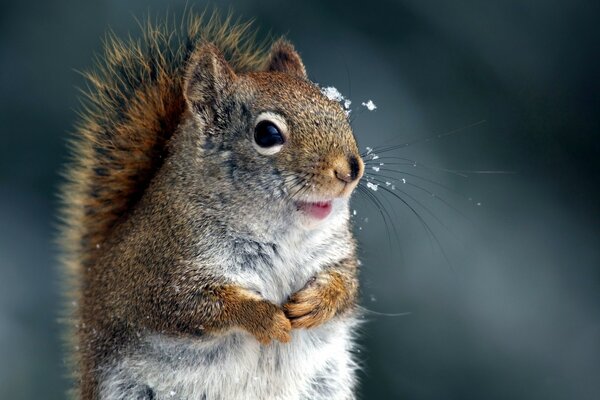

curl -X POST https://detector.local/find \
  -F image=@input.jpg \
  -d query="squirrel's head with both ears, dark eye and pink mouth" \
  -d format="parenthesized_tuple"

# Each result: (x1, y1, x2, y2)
(178, 40, 364, 227)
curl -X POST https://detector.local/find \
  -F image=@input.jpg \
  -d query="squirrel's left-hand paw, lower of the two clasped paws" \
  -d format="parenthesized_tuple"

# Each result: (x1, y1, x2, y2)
(244, 301, 292, 344)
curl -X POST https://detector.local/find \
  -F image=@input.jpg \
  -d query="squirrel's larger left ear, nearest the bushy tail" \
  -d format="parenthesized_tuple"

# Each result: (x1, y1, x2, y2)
(183, 43, 236, 109)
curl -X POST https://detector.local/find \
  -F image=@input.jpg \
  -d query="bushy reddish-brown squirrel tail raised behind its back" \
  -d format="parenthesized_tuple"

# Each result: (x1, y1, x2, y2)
(61, 12, 266, 283)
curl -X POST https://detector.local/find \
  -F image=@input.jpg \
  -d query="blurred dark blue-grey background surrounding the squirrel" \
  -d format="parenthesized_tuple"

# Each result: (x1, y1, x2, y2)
(0, 0, 600, 399)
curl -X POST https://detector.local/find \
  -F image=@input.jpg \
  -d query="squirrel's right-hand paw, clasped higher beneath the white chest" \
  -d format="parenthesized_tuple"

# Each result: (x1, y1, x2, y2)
(283, 276, 340, 329)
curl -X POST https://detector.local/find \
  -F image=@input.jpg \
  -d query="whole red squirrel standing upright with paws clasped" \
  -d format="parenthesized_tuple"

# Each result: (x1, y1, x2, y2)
(61, 14, 364, 400)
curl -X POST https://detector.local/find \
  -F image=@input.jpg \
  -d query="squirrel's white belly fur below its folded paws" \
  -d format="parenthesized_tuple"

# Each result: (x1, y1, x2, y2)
(100, 318, 356, 400)
